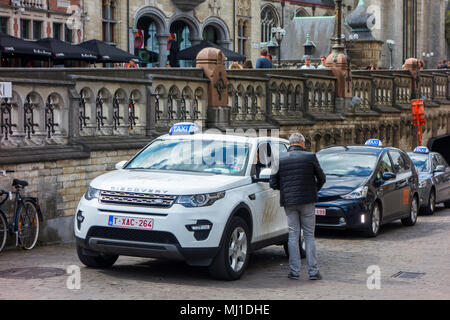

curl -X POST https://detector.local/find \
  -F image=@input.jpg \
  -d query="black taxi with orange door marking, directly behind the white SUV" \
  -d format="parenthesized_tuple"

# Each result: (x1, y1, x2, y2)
(316, 139, 419, 237)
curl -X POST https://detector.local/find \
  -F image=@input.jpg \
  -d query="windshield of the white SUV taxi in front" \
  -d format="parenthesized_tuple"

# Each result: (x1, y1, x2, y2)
(125, 139, 250, 176)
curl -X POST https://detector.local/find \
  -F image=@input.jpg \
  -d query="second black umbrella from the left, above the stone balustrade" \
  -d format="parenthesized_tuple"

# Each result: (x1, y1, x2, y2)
(36, 38, 97, 61)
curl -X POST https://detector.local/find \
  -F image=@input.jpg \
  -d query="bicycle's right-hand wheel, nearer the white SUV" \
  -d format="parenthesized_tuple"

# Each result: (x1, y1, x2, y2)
(17, 201, 39, 250)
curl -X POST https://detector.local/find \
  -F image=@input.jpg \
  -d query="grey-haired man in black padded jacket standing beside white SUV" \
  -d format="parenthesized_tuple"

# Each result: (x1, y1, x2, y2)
(270, 133, 326, 280)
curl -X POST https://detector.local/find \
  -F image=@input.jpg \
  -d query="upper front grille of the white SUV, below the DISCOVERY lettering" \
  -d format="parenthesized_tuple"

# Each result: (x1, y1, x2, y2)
(100, 190, 177, 208)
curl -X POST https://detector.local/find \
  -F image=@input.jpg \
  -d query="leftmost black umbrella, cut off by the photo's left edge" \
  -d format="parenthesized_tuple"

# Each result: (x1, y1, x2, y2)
(0, 32, 52, 59)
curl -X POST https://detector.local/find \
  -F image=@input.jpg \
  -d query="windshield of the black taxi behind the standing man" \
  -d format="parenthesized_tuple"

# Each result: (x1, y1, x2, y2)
(317, 152, 378, 177)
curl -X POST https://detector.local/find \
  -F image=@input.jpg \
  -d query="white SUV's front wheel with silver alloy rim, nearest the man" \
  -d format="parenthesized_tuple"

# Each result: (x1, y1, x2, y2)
(209, 217, 250, 281)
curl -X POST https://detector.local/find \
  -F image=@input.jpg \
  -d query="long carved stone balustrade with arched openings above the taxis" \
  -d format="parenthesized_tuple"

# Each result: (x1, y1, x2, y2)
(0, 68, 450, 158)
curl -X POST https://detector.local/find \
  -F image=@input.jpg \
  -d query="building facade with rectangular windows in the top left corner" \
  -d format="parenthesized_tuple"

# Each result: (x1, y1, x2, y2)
(0, 0, 83, 43)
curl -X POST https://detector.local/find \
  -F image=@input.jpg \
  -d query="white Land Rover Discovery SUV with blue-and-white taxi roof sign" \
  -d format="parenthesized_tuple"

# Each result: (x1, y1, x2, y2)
(74, 123, 304, 280)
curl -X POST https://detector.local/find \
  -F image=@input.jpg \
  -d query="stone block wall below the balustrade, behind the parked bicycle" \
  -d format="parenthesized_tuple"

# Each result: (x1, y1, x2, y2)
(0, 149, 139, 242)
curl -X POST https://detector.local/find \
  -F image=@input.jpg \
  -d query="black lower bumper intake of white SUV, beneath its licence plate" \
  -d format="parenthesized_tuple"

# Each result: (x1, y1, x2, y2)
(86, 226, 178, 245)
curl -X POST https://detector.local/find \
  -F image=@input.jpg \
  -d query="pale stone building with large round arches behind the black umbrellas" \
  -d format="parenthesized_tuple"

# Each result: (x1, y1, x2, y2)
(84, 0, 334, 66)
